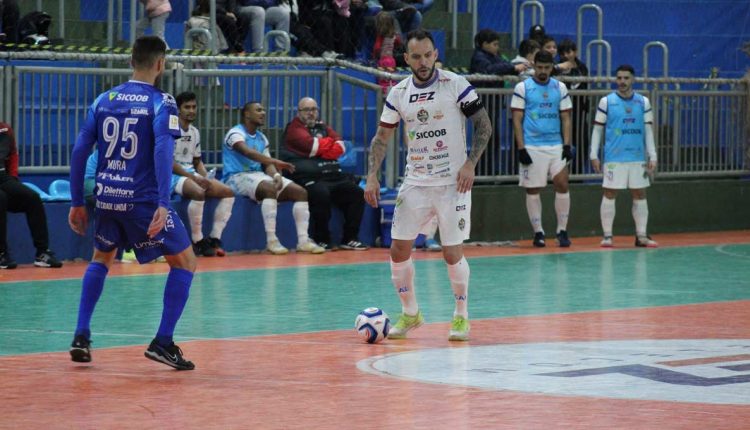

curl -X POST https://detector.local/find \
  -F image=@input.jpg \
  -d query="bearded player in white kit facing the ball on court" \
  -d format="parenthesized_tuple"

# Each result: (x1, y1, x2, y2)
(365, 30, 492, 341)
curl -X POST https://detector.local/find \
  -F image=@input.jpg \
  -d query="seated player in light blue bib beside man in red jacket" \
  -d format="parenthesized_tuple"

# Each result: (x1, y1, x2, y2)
(223, 102, 325, 255)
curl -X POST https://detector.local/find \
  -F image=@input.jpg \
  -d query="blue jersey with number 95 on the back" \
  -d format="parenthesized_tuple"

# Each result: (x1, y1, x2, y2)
(73, 81, 180, 210)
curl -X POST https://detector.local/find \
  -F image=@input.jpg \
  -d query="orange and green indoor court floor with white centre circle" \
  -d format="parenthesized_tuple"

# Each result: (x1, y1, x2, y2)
(0, 231, 750, 430)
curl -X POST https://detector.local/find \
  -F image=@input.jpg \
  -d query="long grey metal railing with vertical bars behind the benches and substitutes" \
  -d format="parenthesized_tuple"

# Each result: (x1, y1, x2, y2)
(0, 52, 750, 186)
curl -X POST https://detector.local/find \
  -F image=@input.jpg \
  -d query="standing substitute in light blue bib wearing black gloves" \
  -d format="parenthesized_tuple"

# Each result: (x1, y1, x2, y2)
(510, 51, 573, 247)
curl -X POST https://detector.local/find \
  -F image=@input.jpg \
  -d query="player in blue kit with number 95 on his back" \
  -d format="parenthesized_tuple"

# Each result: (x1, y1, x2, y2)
(68, 36, 196, 370)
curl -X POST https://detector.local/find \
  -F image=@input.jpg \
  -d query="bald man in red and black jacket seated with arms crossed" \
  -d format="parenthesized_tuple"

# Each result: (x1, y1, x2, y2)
(280, 97, 367, 251)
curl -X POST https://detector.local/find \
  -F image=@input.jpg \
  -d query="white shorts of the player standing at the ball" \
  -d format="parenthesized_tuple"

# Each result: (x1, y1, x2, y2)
(391, 184, 471, 246)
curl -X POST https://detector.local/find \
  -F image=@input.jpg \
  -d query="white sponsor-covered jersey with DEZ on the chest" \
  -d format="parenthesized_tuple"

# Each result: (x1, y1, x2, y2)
(380, 70, 479, 186)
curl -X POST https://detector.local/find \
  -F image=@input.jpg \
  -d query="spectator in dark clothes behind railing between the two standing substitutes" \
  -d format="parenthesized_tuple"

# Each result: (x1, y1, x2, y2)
(558, 39, 589, 171)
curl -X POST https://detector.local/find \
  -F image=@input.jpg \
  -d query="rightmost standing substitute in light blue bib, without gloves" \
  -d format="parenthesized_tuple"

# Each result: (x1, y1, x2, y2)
(589, 64, 658, 248)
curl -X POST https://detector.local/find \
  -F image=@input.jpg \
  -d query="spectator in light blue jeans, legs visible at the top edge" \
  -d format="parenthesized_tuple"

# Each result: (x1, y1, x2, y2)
(238, 0, 291, 52)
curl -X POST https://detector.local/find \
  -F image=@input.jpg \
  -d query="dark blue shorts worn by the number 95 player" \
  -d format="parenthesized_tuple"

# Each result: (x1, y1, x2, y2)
(94, 201, 191, 263)
